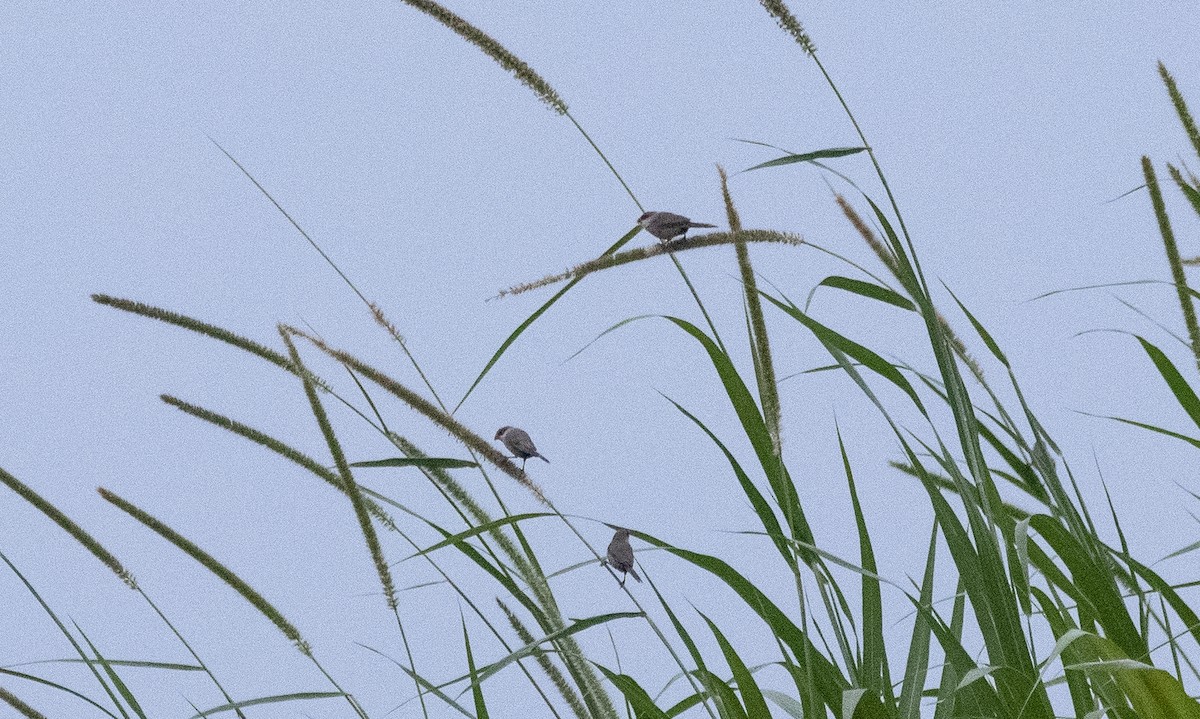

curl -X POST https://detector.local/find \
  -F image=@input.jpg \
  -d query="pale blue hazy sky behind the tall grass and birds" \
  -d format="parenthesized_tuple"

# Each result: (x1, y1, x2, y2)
(0, 0, 1200, 718)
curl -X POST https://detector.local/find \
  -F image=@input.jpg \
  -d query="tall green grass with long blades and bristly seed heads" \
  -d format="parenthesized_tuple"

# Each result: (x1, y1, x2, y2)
(0, 7, 1200, 719)
